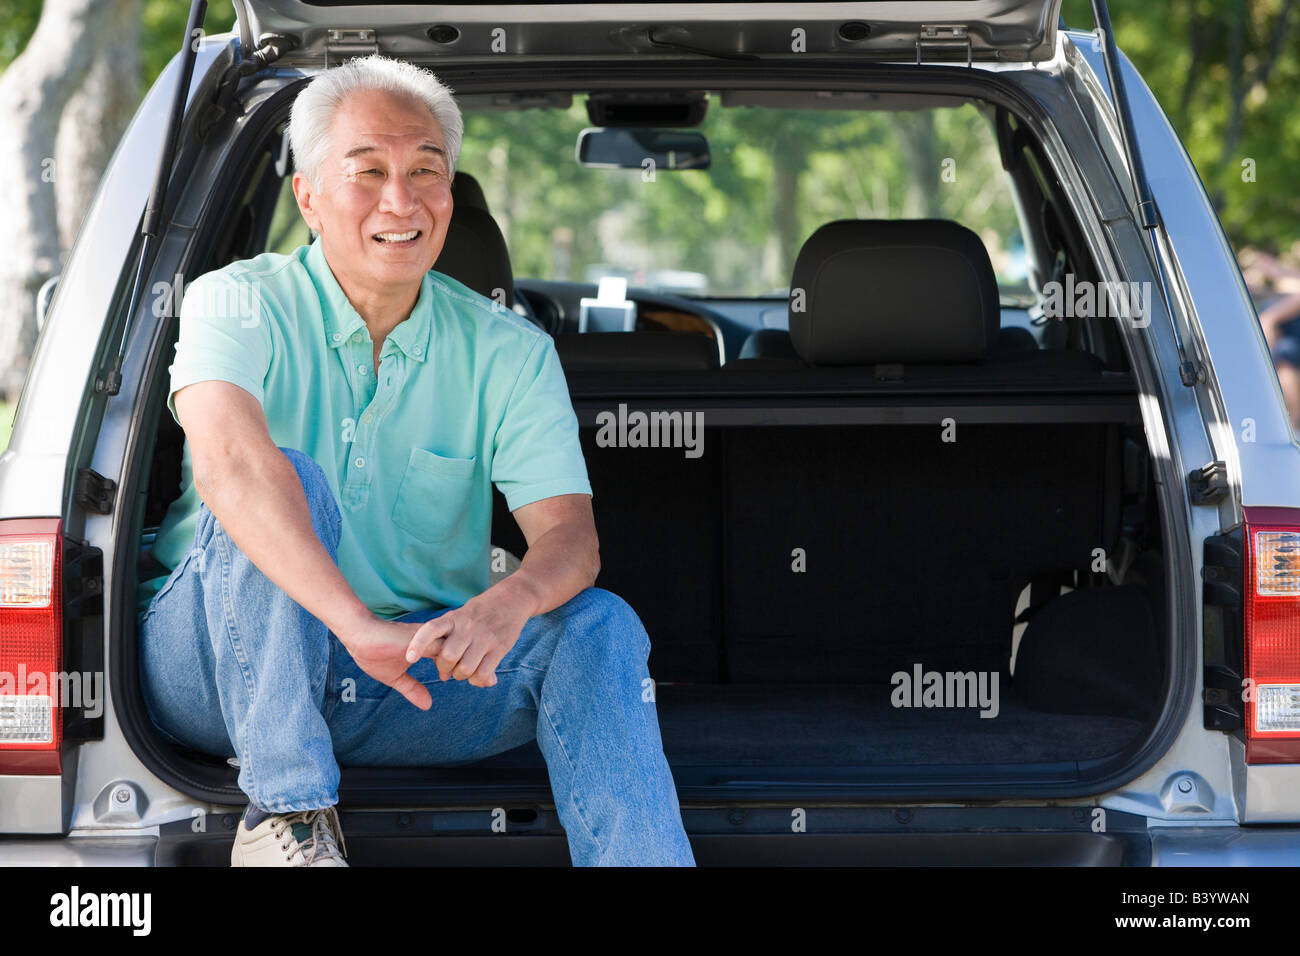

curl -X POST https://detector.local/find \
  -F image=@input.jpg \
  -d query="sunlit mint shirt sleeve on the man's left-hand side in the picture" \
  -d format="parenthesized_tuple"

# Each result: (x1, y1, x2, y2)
(166, 269, 270, 424)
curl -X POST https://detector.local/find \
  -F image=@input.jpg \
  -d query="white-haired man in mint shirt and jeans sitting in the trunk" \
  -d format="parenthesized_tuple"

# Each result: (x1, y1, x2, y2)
(140, 56, 694, 866)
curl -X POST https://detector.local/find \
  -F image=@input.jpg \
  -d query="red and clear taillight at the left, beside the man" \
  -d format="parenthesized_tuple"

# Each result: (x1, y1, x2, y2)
(0, 518, 66, 774)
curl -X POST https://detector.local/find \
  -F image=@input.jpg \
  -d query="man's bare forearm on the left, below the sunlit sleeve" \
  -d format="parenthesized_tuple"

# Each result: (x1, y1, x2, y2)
(195, 446, 374, 640)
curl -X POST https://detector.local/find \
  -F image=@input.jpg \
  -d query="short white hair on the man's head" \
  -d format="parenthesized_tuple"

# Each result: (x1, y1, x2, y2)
(289, 53, 465, 187)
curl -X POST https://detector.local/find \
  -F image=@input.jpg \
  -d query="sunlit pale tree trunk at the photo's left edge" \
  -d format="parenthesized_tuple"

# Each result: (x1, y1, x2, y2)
(0, 0, 117, 401)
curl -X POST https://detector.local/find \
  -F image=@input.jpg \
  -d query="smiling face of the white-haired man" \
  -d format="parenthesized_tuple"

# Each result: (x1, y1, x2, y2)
(294, 90, 451, 299)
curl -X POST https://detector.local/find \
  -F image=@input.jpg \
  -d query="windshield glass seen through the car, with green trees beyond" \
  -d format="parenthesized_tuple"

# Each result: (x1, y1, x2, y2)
(267, 94, 1032, 306)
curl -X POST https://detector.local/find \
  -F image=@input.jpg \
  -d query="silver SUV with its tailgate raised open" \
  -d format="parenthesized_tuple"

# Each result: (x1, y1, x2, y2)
(0, 0, 1300, 866)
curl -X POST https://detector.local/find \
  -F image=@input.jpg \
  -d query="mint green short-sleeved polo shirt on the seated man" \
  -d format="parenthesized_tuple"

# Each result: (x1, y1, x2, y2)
(138, 238, 592, 618)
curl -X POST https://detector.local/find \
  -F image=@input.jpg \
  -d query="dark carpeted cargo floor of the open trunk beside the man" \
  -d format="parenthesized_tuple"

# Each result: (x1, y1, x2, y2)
(478, 684, 1144, 767)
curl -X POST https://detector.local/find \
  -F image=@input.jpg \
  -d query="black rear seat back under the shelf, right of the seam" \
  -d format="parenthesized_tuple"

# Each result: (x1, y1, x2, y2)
(724, 420, 1119, 683)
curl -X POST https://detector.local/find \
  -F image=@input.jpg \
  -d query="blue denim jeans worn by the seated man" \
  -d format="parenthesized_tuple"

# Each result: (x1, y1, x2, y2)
(139, 447, 694, 866)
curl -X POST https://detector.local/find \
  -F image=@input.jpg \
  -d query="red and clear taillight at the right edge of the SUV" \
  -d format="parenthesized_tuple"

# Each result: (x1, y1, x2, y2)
(1243, 509, 1300, 763)
